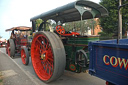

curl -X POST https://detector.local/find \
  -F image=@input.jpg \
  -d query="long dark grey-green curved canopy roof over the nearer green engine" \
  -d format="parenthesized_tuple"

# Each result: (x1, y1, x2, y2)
(30, 0, 108, 22)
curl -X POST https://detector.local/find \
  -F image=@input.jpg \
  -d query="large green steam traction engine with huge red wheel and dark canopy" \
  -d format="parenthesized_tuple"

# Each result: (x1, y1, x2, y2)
(26, 0, 108, 82)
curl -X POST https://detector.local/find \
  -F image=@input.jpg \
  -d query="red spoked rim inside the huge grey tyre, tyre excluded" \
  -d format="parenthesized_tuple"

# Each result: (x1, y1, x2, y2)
(31, 34, 54, 81)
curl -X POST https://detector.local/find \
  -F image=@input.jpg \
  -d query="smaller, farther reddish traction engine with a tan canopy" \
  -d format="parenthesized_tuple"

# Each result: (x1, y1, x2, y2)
(6, 26, 31, 65)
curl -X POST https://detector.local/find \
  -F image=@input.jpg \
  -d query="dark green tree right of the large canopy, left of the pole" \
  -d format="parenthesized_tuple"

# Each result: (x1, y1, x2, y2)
(100, 0, 118, 34)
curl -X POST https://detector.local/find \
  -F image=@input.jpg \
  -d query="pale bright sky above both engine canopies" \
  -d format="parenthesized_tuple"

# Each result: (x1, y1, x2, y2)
(0, 0, 100, 39)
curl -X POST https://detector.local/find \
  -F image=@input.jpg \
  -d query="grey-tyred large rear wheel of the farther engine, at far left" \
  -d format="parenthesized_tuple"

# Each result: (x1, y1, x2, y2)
(6, 39, 15, 58)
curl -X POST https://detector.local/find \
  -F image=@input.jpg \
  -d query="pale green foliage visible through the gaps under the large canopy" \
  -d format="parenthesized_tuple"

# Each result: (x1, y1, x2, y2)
(36, 19, 99, 34)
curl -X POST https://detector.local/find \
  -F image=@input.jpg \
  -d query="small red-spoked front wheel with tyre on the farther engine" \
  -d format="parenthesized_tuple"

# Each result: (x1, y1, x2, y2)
(21, 47, 29, 65)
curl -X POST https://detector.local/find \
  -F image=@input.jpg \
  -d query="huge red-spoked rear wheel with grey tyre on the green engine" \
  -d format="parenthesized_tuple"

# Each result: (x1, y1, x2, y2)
(31, 32, 66, 83)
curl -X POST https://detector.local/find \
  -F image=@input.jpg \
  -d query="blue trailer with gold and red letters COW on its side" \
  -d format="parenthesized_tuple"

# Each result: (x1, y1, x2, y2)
(89, 39, 128, 85)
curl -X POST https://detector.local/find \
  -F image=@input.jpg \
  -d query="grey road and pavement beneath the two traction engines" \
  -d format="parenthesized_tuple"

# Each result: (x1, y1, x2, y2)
(0, 48, 105, 85)
